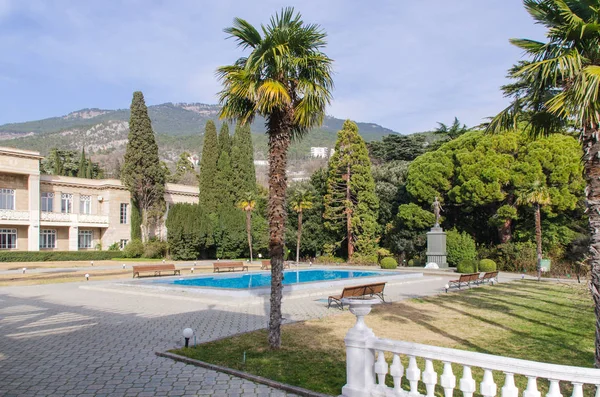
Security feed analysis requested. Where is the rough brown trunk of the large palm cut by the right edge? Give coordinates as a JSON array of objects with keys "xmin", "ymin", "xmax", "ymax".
[{"xmin": 582, "ymin": 126, "xmax": 600, "ymax": 368}]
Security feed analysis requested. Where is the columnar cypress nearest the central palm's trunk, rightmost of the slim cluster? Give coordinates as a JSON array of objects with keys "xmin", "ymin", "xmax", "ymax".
[{"xmin": 231, "ymin": 124, "xmax": 256, "ymax": 203}]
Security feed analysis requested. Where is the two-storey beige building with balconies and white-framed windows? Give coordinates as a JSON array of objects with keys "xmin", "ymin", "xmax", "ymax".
[{"xmin": 0, "ymin": 147, "xmax": 198, "ymax": 251}]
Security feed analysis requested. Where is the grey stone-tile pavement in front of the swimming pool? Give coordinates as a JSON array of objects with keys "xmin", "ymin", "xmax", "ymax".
[{"xmin": 0, "ymin": 270, "xmax": 458, "ymax": 397}]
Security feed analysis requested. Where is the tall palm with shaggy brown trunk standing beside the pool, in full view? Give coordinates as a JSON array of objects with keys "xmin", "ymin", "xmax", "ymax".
[{"xmin": 217, "ymin": 8, "xmax": 333, "ymax": 349}]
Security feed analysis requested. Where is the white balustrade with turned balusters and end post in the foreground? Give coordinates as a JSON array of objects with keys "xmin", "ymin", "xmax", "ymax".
[{"xmin": 342, "ymin": 299, "xmax": 600, "ymax": 397}]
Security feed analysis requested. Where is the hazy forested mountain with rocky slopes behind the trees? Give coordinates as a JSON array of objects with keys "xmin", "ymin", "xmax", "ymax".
[{"xmin": 0, "ymin": 103, "xmax": 395, "ymax": 169}]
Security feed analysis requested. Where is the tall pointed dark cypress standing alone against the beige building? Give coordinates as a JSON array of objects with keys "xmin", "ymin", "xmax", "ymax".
[{"xmin": 121, "ymin": 91, "xmax": 165, "ymax": 242}]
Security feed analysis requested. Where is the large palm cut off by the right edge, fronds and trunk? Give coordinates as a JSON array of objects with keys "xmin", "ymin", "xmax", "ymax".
[{"xmin": 487, "ymin": 0, "xmax": 600, "ymax": 367}]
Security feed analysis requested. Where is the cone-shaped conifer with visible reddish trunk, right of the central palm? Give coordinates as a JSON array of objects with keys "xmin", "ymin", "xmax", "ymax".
[{"xmin": 324, "ymin": 120, "xmax": 379, "ymax": 259}]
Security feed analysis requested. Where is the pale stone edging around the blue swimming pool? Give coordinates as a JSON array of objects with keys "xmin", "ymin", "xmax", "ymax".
[{"xmin": 119, "ymin": 266, "xmax": 423, "ymax": 298}]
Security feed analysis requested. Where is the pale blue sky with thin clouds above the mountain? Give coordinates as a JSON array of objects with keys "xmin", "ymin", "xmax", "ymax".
[{"xmin": 0, "ymin": 0, "xmax": 544, "ymax": 134}]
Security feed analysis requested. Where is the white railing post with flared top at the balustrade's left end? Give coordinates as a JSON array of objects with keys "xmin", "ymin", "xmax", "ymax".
[{"xmin": 342, "ymin": 299, "xmax": 380, "ymax": 397}]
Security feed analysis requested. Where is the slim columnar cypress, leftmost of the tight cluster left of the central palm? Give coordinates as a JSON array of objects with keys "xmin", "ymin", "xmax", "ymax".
[{"xmin": 199, "ymin": 120, "xmax": 220, "ymax": 213}]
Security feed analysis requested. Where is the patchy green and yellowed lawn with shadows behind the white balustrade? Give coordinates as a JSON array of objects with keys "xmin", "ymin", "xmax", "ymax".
[{"xmin": 174, "ymin": 281, "xmax": 594, "ymax": 395}]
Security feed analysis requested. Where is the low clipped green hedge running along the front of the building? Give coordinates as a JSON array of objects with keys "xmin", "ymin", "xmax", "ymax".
[{"xmin": 0, "ymin": 251, "xmax": 122, "ymax": 262}]
